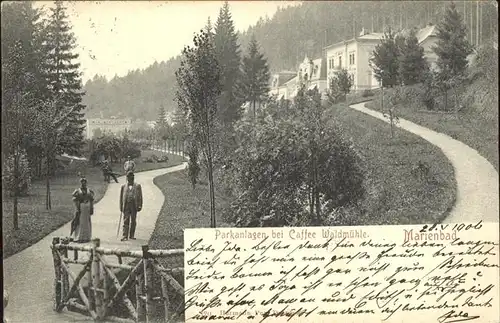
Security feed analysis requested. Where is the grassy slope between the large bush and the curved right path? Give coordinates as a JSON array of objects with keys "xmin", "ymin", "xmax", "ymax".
[{"xmin": 329, "ymin": 104, "xmax": 456, "ymax": 225}]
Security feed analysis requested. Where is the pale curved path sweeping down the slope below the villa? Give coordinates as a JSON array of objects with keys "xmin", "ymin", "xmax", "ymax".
[{"xmin": 350, "ymin": 102, "xmax": 499, "ymax": 223}]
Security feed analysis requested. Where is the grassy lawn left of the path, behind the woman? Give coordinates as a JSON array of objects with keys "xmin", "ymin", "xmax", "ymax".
[{"xmin": 2, "ymin": 151, "xmax": 183, "ymax": 259}]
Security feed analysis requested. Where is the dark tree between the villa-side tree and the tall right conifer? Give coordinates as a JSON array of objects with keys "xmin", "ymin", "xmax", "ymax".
[{"xmin": 399, "ymin": 30, "xmax": 428, "ymax": 85}]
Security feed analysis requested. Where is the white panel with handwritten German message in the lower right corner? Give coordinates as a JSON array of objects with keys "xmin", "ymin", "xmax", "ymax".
[{"xmin": 184, "ymin": 223, "xmax": 500, "ymax": 323}]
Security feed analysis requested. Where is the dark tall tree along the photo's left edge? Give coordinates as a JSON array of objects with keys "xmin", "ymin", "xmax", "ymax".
[{"xmin": 1, "ymin": 1, "xmax": 44, "ymax": 230}]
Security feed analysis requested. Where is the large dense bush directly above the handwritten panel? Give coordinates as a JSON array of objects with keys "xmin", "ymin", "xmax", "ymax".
[{"xmin": 222, "ymin": 91, "xmax": 364, "ymax": 227}]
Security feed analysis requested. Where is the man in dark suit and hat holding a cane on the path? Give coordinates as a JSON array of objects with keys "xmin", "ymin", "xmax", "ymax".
[{"xmin": 120, "ymin": 172, "xmax": 142, "ymax": 241}]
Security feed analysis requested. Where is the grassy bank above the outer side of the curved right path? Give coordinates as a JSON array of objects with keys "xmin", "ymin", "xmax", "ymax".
[{"xmin": 366, "ymin": 93, "xmax": 499, "ymax": 171}]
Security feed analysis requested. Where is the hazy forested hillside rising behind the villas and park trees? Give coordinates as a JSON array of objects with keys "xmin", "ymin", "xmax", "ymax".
[{"xmin": 84, "ymin": 1, "xmax": 498, "ymax": 120}]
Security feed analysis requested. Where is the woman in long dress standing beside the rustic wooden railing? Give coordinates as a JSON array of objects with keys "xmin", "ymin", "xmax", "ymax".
[{"xmin": 71, "ymin": 178, "xmax": 94, "ymax": 242}]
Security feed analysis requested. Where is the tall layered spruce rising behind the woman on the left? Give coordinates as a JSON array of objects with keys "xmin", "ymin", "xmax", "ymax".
[{"xmin": 44, "ymin": 1, "xmax": 85, "ymax": 155}]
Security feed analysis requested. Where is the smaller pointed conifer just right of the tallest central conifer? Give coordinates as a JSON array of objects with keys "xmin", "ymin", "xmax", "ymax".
[{"xmin": 239, "ymin": 36, "xmax": 270, "ymax": 118}]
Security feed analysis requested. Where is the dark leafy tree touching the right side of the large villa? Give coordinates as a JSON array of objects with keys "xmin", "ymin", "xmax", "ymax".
[{"xmin": 370, "ymin": 28, "xmax": 399, "ymax": 87}]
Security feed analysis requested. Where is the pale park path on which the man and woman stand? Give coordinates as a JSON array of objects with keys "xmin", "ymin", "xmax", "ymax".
[{"xmin": 3, "ymin": 163, "xmax": 186, "ymax": 323}]
